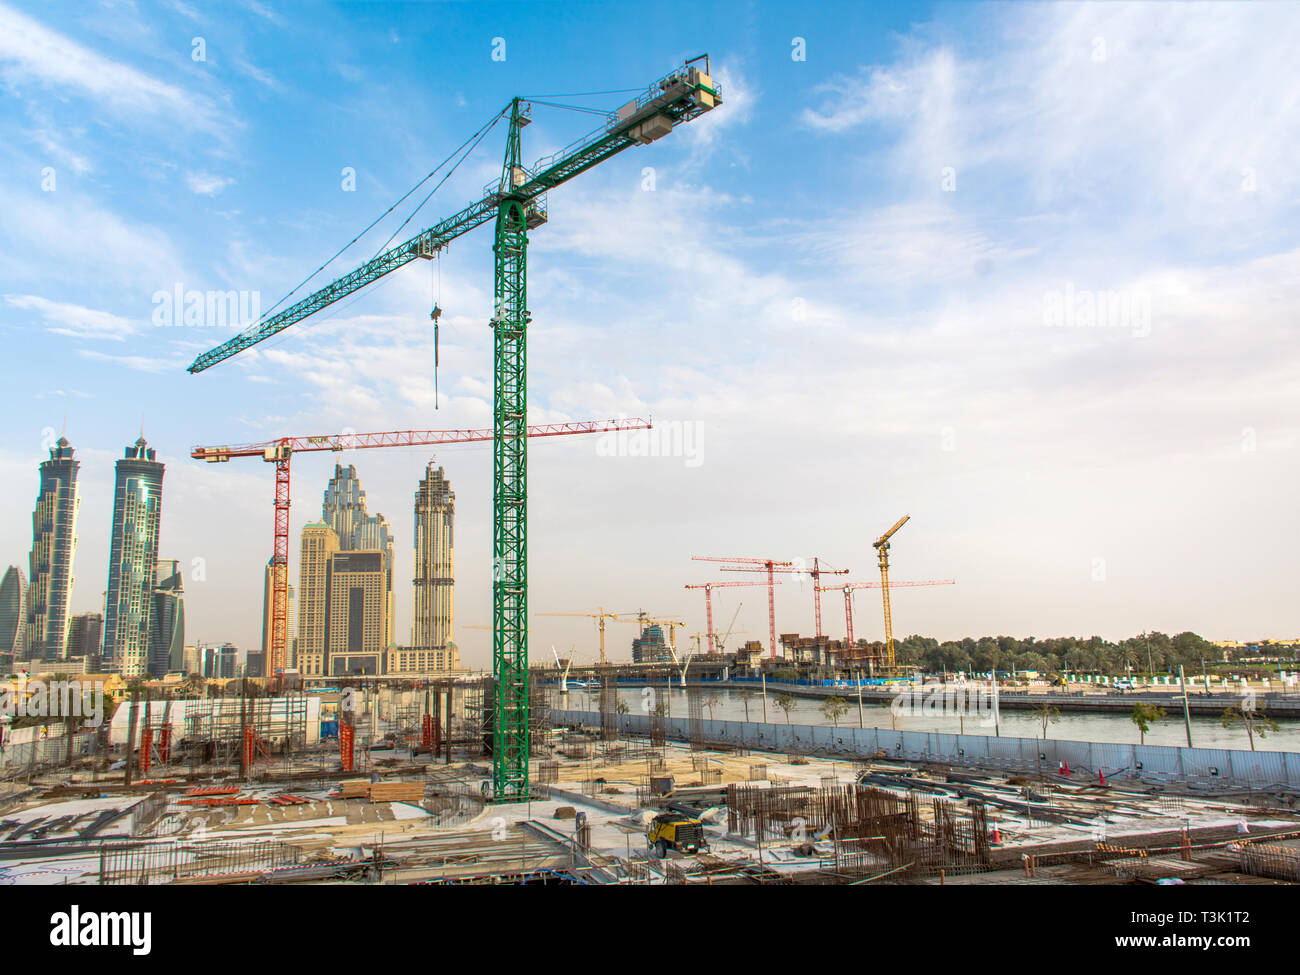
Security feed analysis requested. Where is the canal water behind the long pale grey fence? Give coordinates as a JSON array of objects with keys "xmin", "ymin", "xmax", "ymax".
[{"xmin": 559, "ymin": 684, "xmax": 1300, "ymax": 751}]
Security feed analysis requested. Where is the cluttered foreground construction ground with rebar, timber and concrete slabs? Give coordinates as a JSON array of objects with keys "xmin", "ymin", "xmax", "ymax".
[{"xmin": 0, "ymin": 670, "xmax": 1300, "ymax": 885}]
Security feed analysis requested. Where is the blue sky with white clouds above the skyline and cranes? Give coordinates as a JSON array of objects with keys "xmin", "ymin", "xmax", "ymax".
[{"xmin": 0, "ymin": 1, "xmax": 1300, "ymax": 664}]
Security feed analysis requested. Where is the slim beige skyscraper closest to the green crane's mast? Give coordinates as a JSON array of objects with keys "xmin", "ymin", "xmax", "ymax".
[{"xmin": 411, "ymin": 462, "xmax": 456, "ymax": 650}]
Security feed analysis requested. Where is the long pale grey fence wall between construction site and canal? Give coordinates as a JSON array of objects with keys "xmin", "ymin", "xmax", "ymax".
[{"xmin": 551, "ymin": 710, "xmax": 1300, "ymax": 789}]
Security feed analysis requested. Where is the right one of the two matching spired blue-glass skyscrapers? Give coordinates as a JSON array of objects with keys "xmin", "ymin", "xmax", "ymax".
[{"xmin": 104, "ymin": 437, "xmax": 163, "ymax": 677}]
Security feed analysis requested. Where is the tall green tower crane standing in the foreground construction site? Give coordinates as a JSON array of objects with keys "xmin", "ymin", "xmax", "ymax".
[{"xmin": 189, "ymin": 55, "xmax": 722, "ymax": 801}]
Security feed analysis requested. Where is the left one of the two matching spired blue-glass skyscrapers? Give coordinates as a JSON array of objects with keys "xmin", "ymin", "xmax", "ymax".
[{"xmin": 26, "ymin": 437, "xmax": 81, "ymax": 660}]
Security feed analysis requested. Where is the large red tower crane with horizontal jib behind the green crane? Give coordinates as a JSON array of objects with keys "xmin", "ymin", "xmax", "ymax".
[{"xmin": 190, "ymin": 419, "xmax": 650, "ymax": 677}]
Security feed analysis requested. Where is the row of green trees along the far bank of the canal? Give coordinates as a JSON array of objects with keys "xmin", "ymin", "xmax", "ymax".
[{"xmin": 894, "ymin": 632, "xmax": 1242, "ymax": 673}]
